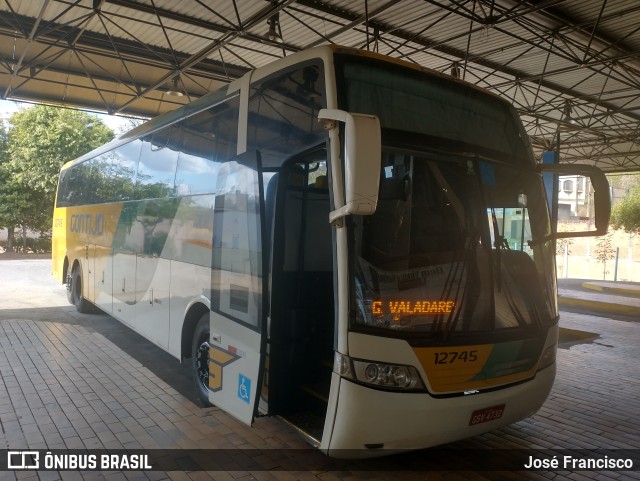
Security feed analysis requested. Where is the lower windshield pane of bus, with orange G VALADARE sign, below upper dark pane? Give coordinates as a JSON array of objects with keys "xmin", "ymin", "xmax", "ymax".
[{"xmin": 352, "ymin": 150, "xmax": 555, "ymax": 337}]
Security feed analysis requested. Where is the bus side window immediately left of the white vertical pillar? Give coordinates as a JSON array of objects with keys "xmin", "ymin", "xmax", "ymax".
[{"xmin": 175, "ymin": 97, "xmax": 239, "ymax": 195}]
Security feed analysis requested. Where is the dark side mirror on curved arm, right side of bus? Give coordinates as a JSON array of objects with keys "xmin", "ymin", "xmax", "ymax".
[{"xmin": 538, "ymin": 164, "xmax": 611, "ymax": 239}]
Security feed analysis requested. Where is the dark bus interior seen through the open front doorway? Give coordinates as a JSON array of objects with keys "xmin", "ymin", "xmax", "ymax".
[{"xmin": 263, "ymin": 148, "xmax": 335, "ymax": 443}]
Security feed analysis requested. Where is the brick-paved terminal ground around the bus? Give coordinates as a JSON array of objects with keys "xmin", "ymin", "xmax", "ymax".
[{"xmin": 0, "ymin": 255, "xmax": 640, "ymax": 481}]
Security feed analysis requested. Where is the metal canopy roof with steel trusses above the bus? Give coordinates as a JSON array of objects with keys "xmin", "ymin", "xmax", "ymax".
[{"xmin": 0, "ymin": 0, "xmax": 640, "ymax": 172}]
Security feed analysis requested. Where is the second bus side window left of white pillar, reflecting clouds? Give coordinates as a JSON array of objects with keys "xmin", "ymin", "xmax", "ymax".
[{"xmin": 136, "ymin": 126, "xmax": 182, "ymax": 199}]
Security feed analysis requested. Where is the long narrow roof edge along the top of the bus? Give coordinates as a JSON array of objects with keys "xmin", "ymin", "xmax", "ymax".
[{"xmin": 62, "ymin": 44, "xmax": 511, "ymax": 169}]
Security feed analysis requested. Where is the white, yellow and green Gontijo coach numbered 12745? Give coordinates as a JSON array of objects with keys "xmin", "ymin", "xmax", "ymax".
[{"xmin": 52, "ymin": 46, "xmax": 609, "ymax": 457}]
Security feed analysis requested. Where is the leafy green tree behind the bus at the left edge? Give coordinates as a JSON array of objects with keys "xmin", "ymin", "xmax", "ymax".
[{"xmin": 0, "ymin": 105, "xmax": 113, "ymax": 248}]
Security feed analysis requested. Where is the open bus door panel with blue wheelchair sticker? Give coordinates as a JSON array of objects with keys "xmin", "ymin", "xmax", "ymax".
[{"xmin": 209, "ymin": 152, "xmax": 267, "ymax": 425}]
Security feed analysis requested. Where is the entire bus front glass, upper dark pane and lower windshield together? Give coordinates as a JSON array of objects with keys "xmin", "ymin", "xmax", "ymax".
[{"xmin": 336, "ymin": 56, "xmax": 557, "ymax": 340}]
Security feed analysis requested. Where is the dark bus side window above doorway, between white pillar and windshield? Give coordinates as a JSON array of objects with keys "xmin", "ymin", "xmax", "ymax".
[{"xmin": 247, "ymin": 61, "xmax": 326, "ymax": 168}]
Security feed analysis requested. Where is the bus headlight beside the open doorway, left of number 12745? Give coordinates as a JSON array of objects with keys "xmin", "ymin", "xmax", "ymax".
[{"xmin": 334, "ymin": 352, "xmax": 426, "ymax": 391}]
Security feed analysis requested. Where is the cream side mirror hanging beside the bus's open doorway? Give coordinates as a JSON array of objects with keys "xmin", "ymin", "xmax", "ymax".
[{"xmin": 318, "ymin": 109, "xmax": 382, "ymax": 222}]
